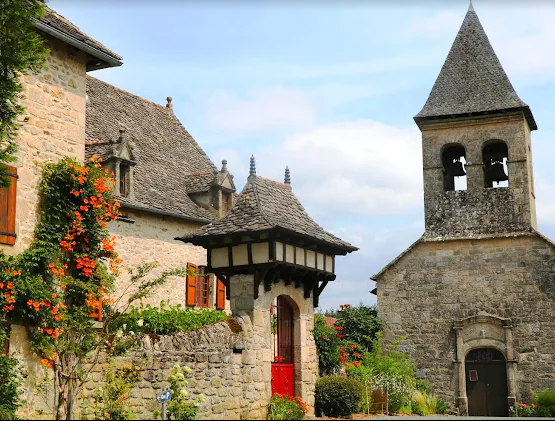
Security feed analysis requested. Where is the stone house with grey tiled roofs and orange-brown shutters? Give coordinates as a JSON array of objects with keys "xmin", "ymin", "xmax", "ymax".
[{"xmin": 0, "ymin": 3, "xmax": 235, "ymax": 309}]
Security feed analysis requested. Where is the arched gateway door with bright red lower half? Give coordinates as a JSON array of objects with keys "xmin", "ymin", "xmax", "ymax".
[{"xmin": 270, "ymin": 295, "xmax": 295, "ymax": 397}]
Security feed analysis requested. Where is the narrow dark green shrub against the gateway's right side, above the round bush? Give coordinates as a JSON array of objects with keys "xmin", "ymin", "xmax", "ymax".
[{"xmin": 312, "ymin": 314, "xmax": 341, "ymax": 376}]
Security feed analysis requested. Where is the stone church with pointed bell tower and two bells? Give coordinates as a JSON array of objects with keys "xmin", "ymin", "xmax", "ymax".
[{"xmin": 372, "ymin": 6, "xmax": 555, "ymax": 416}]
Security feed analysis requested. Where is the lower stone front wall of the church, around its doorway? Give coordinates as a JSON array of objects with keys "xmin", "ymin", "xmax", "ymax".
[{"xmin": 377, "ymin": 234, "xmax": 555, "ymax": 407}]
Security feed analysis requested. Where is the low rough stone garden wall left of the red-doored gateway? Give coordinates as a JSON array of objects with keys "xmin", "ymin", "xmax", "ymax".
[{"xmin": 78, "ymin": 318, "xmax": 270, "ymax": 420}]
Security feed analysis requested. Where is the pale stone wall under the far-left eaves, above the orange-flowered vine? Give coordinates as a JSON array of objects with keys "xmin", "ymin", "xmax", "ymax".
[{"xmin": 0, "ymin": 37, "xmax": 86, "ymax": 254}]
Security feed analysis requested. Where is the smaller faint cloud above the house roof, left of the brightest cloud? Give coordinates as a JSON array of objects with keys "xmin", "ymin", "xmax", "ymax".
[{"xmin": 206, "ymin": 87, "xmax": 316, "ymax": 133}]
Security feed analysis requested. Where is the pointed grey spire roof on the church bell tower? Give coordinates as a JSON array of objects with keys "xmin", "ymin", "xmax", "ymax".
[{"xmin": 414, "ymin": 5, "xmax": 537, "ymax": 130}]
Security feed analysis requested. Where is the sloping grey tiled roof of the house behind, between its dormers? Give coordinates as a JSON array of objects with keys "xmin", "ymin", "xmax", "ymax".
[{"xmin": 85, "ymin": 76, "xmax": 217, "ymax": 222}]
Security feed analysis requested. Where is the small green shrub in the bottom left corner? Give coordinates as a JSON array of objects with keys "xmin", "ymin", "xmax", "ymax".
[{"xmin": 0, "ymin": 355, "xmax": 23, "ymax": 420}]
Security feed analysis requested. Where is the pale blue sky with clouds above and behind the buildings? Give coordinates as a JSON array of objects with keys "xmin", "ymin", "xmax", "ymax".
[{"xmin": 48, "ymin": 0, "xmax": 555, "ymax": 309}]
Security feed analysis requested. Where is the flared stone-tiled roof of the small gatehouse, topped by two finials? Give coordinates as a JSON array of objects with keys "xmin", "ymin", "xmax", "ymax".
[{"xmin": 180, "ymin": 171, "xmax": 358, "ymax": 254}]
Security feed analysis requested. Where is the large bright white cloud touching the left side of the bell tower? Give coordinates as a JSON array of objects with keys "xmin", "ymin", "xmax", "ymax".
[{"xmin": 257, "ymin": 120, "xmax": 422, "ymax": 217}]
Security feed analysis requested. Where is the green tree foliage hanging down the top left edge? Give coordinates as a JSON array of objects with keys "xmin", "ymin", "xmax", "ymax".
[{"xmin": 0, "ymin": 0, "xmax": 48, "ymax": 188}]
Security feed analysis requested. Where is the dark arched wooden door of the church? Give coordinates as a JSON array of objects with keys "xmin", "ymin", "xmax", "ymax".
[{"xmin": 465, "ymin": 348, "xmax": 509, "ymax": 417}]
